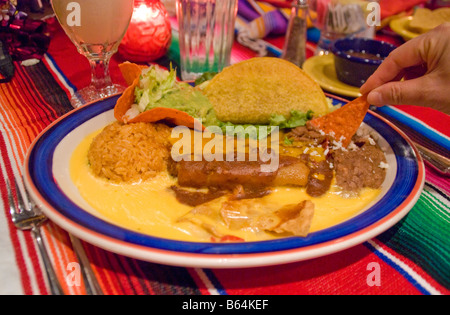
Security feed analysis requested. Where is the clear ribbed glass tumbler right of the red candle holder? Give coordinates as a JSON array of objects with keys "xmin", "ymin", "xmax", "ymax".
[{"xmin": 177, "ymin": 0, "xmax": 238, "ymax": 80}]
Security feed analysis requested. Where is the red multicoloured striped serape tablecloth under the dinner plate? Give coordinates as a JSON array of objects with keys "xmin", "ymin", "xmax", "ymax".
[{"xmin": 0, "ymin": 5, "xmax": 450, "ymax": 295}]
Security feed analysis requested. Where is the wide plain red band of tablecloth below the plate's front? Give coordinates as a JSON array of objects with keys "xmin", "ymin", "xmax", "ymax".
[{"xmin": 209, "ymin": 245, "xmax": 420, "ymax": 295}]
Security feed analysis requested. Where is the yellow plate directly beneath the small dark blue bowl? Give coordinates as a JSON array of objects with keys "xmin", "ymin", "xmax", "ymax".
[{"xmin": 303, "ymin": 55, "xmax": 361, "ymax": 98}]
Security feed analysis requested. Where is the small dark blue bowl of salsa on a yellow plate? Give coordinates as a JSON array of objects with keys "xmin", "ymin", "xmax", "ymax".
[{"xmin": 331, "ymin": 38, "xmax": 396, "ymax": 87}]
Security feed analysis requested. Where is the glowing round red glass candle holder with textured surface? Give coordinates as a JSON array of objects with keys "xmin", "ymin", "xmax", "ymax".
[{"xmin": 119, "ymin": 0, "xmax": 172, "ymax": 62}]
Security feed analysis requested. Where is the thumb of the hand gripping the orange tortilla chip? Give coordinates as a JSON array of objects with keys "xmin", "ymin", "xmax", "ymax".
[{"xmin": 367, "ymin": 77, "xmax": 430, "ymax": 106}]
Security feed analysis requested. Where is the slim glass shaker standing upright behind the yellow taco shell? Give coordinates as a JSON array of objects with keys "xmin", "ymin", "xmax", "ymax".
[{"xmin": 281, "ymin": 0, "xmax": 308, "ymax": 67}]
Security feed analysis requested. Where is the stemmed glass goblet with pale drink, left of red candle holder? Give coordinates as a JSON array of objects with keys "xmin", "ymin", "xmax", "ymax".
[{"xmin": 52, "ymin": 0, "xmax": 134, "ymax": 108}]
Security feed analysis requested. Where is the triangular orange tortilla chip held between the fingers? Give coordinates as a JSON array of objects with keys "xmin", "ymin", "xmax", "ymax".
[{"xmin": 308, "ymin": 95, "xmax": 370, "ymax": 148}]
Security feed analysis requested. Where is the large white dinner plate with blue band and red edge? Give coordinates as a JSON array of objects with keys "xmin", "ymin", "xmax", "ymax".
[{"xmin": 24, "ymin": 95, "xmax": 425, "ymax": 268}]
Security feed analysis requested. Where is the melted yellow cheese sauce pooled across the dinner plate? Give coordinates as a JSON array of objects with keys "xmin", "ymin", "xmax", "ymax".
[{"xmin": 70, "ymin": 131, "xmax": 380, "ymax": 242}]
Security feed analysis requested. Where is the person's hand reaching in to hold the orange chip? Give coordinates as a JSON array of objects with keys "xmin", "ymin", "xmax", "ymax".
[{"xmin": 360, "ymin": 23, "xmax": 450, "ymax": 114}]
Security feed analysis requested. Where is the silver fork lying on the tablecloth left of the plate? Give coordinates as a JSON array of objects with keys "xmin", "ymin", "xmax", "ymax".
[{"xmin": 6, "ymin": 180, "xmax": 64, "ymax": 295}]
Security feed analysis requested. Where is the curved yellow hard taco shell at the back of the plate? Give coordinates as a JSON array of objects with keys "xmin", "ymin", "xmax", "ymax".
[{"xmin": 204, "ymin": 57, "xmax": 329, "ymax": 125}]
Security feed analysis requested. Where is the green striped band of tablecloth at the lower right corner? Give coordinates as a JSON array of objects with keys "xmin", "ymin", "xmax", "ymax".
[{"xmin": 378, "ymin": 186, "xmax": 450, "ymax": 289}]
